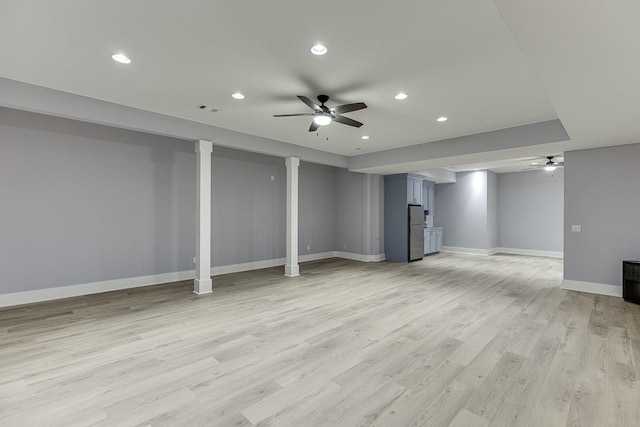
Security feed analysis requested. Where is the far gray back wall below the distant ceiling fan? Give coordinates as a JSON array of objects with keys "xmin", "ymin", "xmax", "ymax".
[{"xmin": 498, "ymin": 168, "xmax": 564, "ymax": 252}]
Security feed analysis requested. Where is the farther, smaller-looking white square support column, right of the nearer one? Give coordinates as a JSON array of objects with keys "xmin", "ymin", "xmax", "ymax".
[{"xmin": 284, "ymin": 157, "xmax": 300, "ymax": 277}]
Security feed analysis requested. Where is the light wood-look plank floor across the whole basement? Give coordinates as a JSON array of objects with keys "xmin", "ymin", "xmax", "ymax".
[{"xmin": 0, "ymin": 253, "xmax": 640, "ymax": 427}]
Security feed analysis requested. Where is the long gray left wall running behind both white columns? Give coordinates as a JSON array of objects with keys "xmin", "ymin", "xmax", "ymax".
[{"xmin": 0, "ymin": 108, "xmax": 381, "ymax": 293}]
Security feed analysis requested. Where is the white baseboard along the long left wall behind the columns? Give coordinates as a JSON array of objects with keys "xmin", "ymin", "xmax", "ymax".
[{"xmin": 0, "ymin": 251, "xmax": 385, "ymax": 307}]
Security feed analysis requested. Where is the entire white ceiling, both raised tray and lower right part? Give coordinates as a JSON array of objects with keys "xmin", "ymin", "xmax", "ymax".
[{"xmin": 0, "ymin": 0, "xmax": 640, "ymax": 173}]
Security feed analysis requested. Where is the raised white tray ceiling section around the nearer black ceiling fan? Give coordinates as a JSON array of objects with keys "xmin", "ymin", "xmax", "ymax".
[{"xmin": 0, "ymin": 0, "xmax": 556, "ymax": 155}]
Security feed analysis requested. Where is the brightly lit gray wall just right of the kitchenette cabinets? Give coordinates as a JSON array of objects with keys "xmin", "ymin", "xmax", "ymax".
[{"xmin": 434, "ymin": 171, "xmax": 492, "ymax": 249}]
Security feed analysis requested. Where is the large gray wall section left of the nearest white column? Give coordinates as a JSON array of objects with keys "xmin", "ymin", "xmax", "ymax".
[{"xmin": 0, "ymin": 108, "xmax": 195, "ymax": 293}]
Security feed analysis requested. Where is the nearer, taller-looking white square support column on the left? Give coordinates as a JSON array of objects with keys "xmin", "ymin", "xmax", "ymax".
[{"xmin": 193, "ymin": 139, "xmax": 213, "ymax": 295}]
